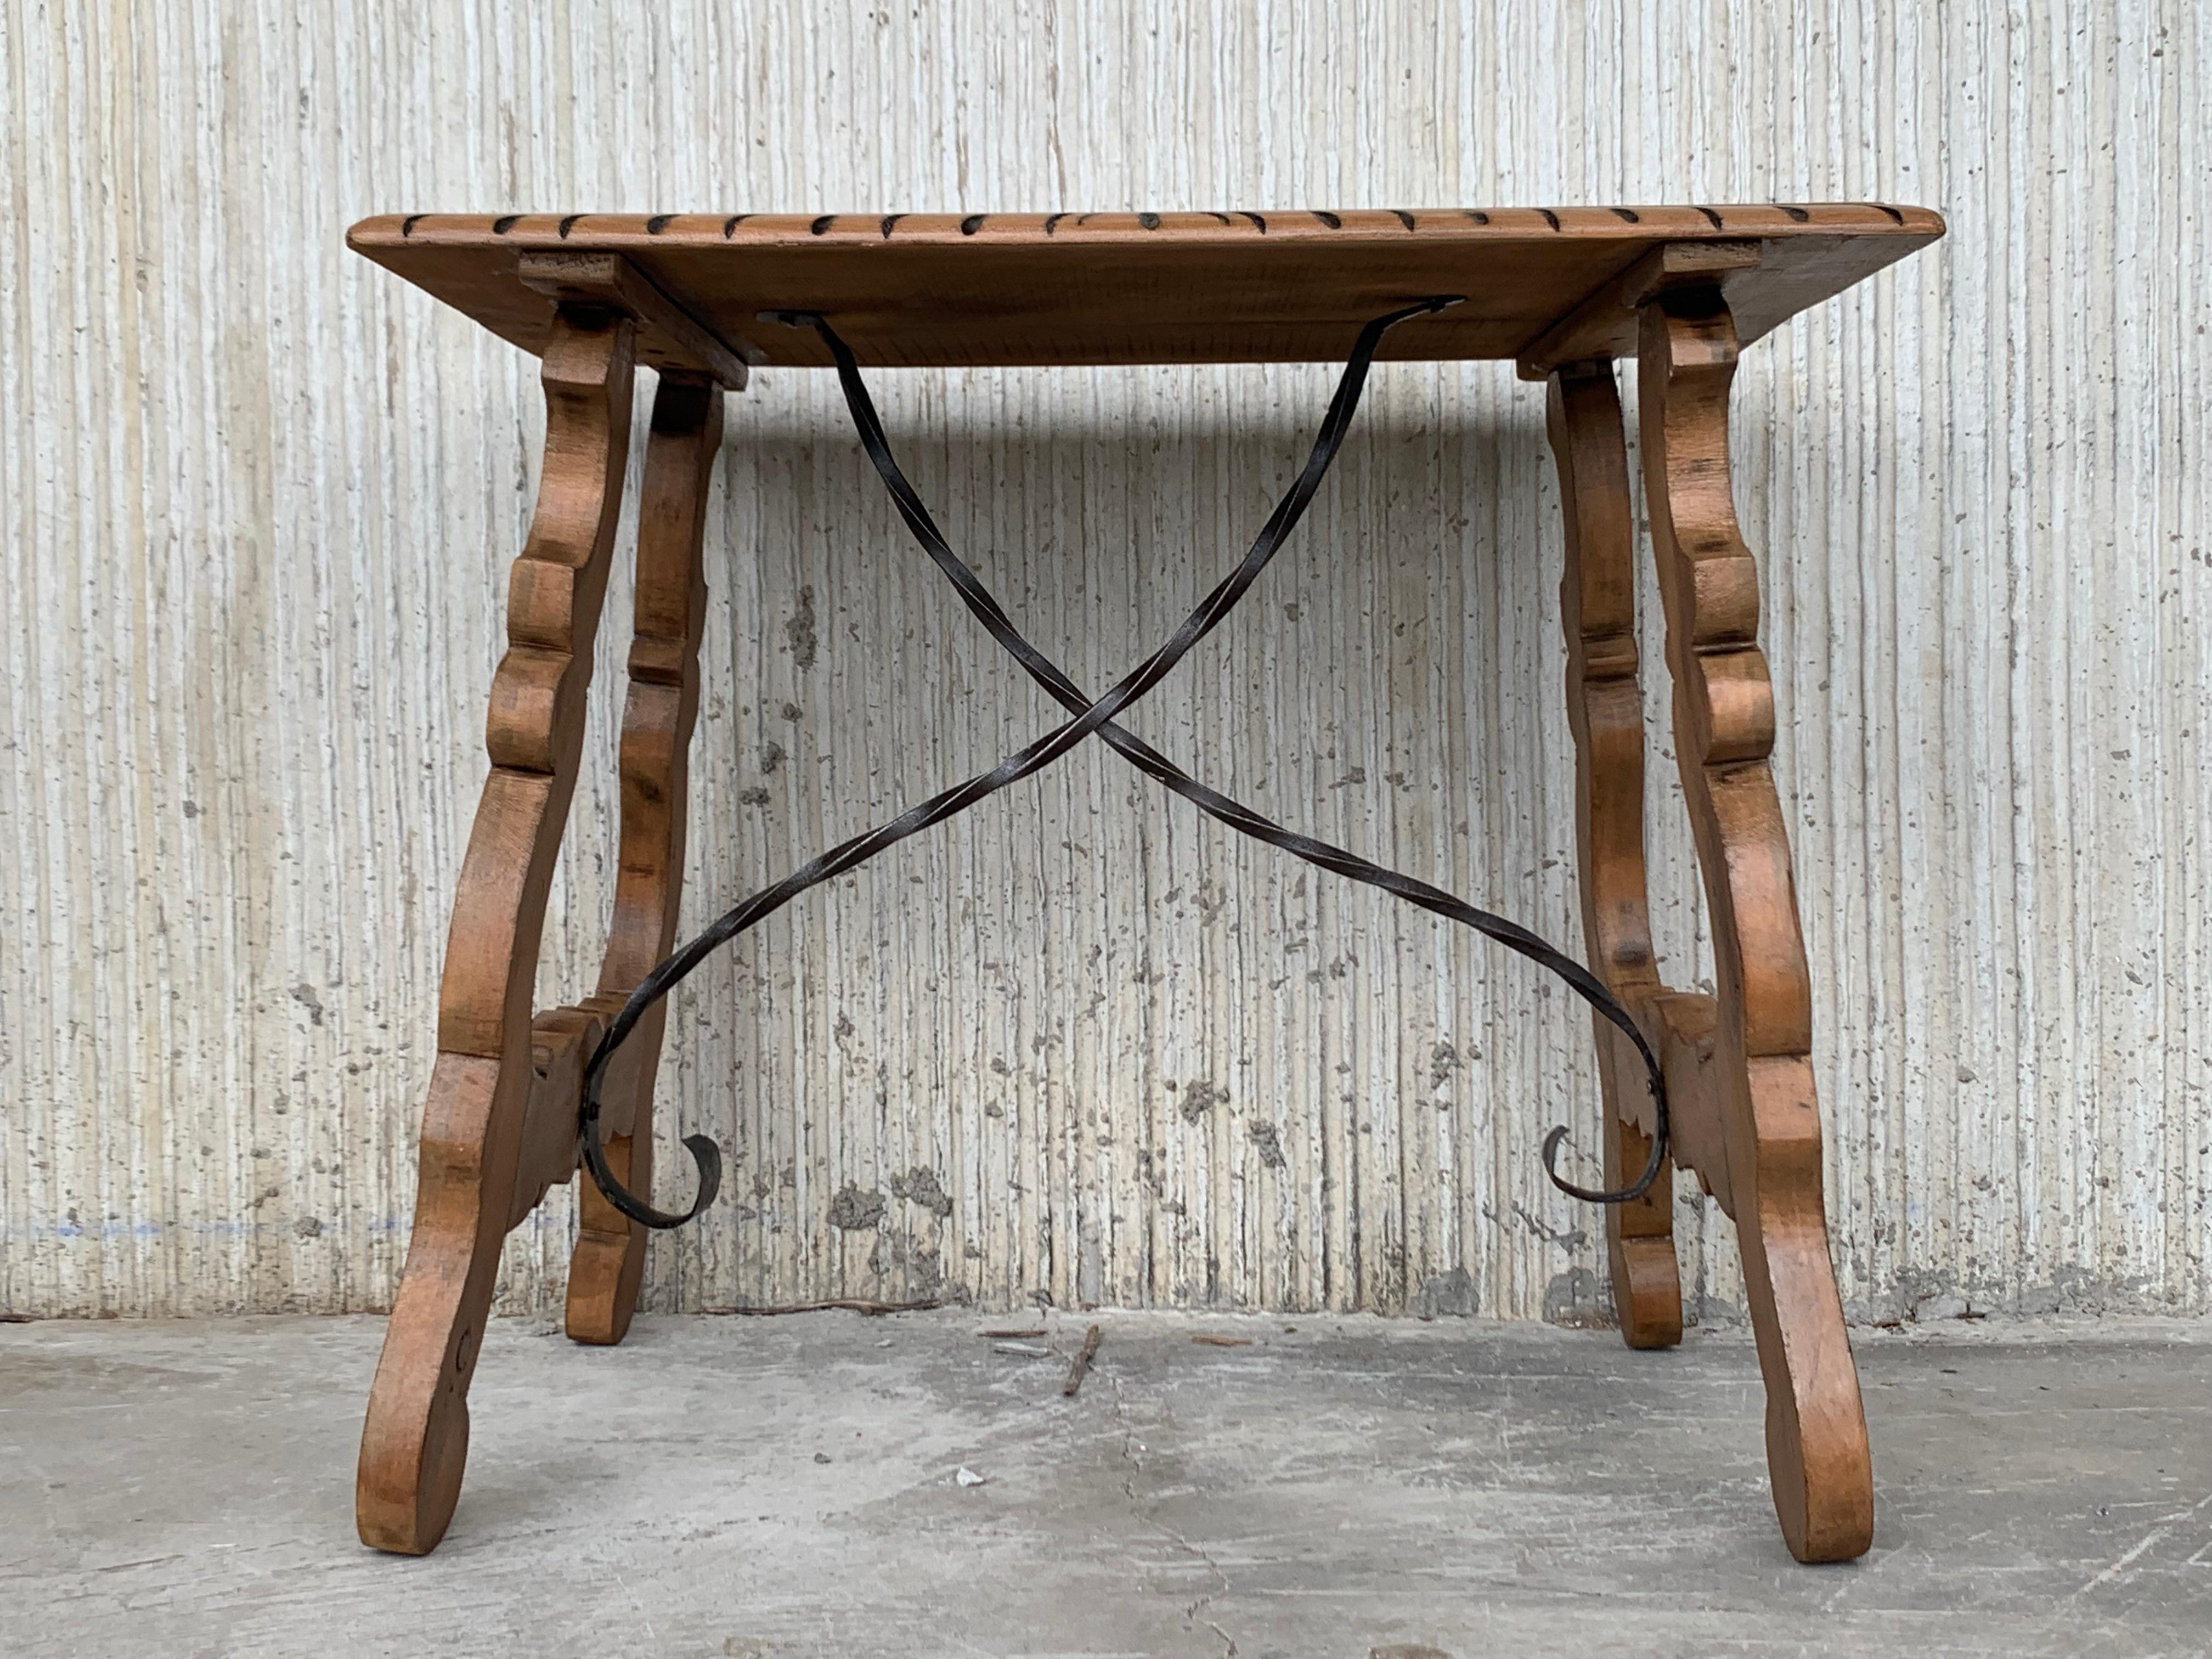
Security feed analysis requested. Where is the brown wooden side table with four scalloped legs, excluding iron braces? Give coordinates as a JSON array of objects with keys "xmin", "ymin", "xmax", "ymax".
[{"xmin": 347, "ymin": 204, "xmax": 1942, "ymax": 1562}]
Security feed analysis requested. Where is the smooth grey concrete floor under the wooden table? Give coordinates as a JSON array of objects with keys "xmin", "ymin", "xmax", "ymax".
[{"xmin": 0, "ymin": 1312, "xmax": 2212, "ymax": 1659}]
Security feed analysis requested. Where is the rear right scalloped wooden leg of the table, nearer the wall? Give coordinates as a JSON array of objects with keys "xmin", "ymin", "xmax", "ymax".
[{"xmin": 1548, "ymin": 363, "xmax": 1681, "ymax": 1347}]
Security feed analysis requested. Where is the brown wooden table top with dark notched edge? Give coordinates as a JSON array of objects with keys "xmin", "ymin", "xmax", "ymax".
[{"xmin": 347, "ymin": 204, "xmax": 1944, "ymax": 367}]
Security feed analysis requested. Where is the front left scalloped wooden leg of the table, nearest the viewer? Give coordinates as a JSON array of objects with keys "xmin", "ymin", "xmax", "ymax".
[{"xmin": 354, "ymin": 309, "xmax": 633, "ymax": 1555}]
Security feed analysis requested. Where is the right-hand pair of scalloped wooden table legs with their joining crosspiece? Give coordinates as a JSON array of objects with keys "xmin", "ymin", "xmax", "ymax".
[{"xmin": 1550, "ymin": 281, "xmax": 1874, "ymax": 1562}]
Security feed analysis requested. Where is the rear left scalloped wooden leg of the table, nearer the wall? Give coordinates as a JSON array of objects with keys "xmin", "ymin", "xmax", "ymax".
[{"xmin": 568, "ymin": 376, "xmax": 721, "ymax": 1342}]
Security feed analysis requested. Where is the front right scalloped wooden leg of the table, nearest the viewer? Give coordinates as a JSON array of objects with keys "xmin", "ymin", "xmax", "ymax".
[{"xmin": 1637, "ymin": 287, "xmax": 1874, "ymax": 1562}]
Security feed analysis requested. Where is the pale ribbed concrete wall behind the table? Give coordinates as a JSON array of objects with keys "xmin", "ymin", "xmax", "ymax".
[{"xmin": 0, "ymin": 0, "xmax": 2212, "ymax": 1316}]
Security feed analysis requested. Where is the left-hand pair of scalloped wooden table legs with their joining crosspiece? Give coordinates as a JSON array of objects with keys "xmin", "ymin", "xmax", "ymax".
[{"xmin": 354, "ymin": 296, "xmax": 721, "ymax": 1555}]
